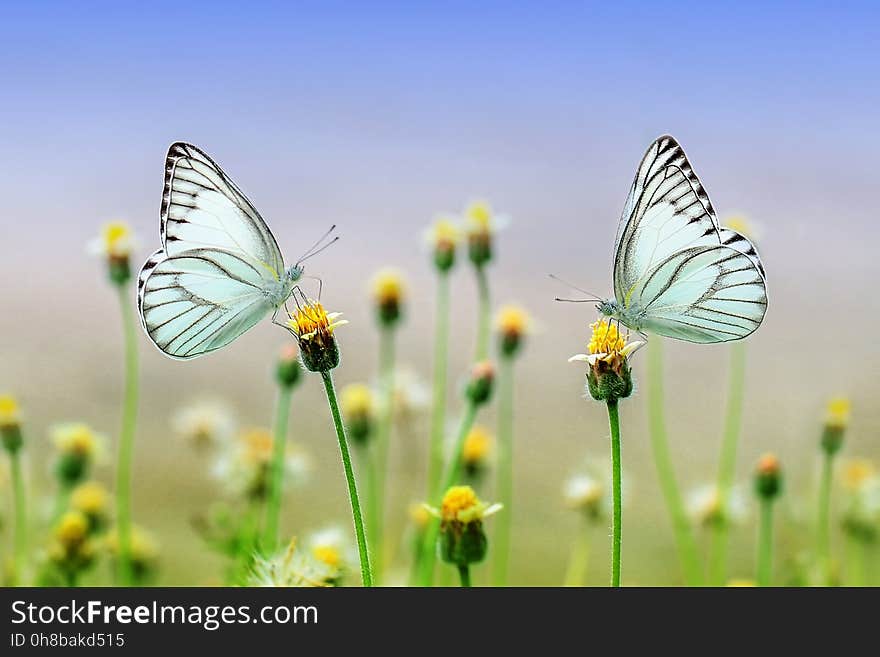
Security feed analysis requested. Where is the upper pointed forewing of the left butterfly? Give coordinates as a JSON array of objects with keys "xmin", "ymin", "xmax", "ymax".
[{"xmin": 161, "ymin": 142, "xmax": 284, "ymax": 280}]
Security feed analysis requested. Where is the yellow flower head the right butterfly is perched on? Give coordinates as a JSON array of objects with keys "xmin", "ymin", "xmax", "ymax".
[{"xmin": 568, "ymin": 319, "xmax": 645, "ymax": 401}]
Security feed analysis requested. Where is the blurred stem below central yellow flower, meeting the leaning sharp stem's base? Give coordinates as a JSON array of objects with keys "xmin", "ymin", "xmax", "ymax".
[{"xmin": 370, "ymin": 326, "xmax": 394, "ymax": 581}]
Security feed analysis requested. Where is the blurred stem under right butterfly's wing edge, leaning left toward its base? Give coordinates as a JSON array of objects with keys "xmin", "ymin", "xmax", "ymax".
[{"xmin": 709, "ymin": 341, "xmax": 746, "ymax": 586}]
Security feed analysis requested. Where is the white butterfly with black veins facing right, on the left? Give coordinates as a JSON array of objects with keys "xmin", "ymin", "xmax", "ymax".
[{"xmin": 138, "ymin": 142, "xmax": 335, "ymax": 360}]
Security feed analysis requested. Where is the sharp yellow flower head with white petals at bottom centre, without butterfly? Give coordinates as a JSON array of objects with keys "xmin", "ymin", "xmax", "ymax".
[{"xmin": 431, "ymin": 486, "xmax": 501, "ymax": 566}]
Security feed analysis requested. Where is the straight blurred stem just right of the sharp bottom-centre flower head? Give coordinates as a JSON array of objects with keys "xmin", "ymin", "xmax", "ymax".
[{"xmin": 492, "ymin": 356, "xmax": 514, "ymax": 586}]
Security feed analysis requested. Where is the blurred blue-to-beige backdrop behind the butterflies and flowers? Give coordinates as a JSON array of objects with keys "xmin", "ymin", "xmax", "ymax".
[{"xmin": 0, "ymin": 1, "xmax": 880, "ymax": 585}]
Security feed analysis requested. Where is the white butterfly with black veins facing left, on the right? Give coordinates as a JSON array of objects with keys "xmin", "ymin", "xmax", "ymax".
[{"xmin": 597, "ymin": 135, "xmax": 767, "ymax": 343}]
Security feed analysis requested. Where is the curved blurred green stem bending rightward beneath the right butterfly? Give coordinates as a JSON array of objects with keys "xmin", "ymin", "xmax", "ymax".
[{"xmin": 648, "ymin": 338, "xmax": 703, "ymax": 586}]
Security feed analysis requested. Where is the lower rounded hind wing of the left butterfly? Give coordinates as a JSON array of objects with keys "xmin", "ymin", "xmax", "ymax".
[{"xmin": 138, "ymin": 248, "xmax": 273, "ymax": 360}]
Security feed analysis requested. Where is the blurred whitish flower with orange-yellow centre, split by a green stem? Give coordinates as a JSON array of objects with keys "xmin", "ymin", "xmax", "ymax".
[{"xmin": 214, "ymin": 427, "xmax": 309, "ymax": 500}]
